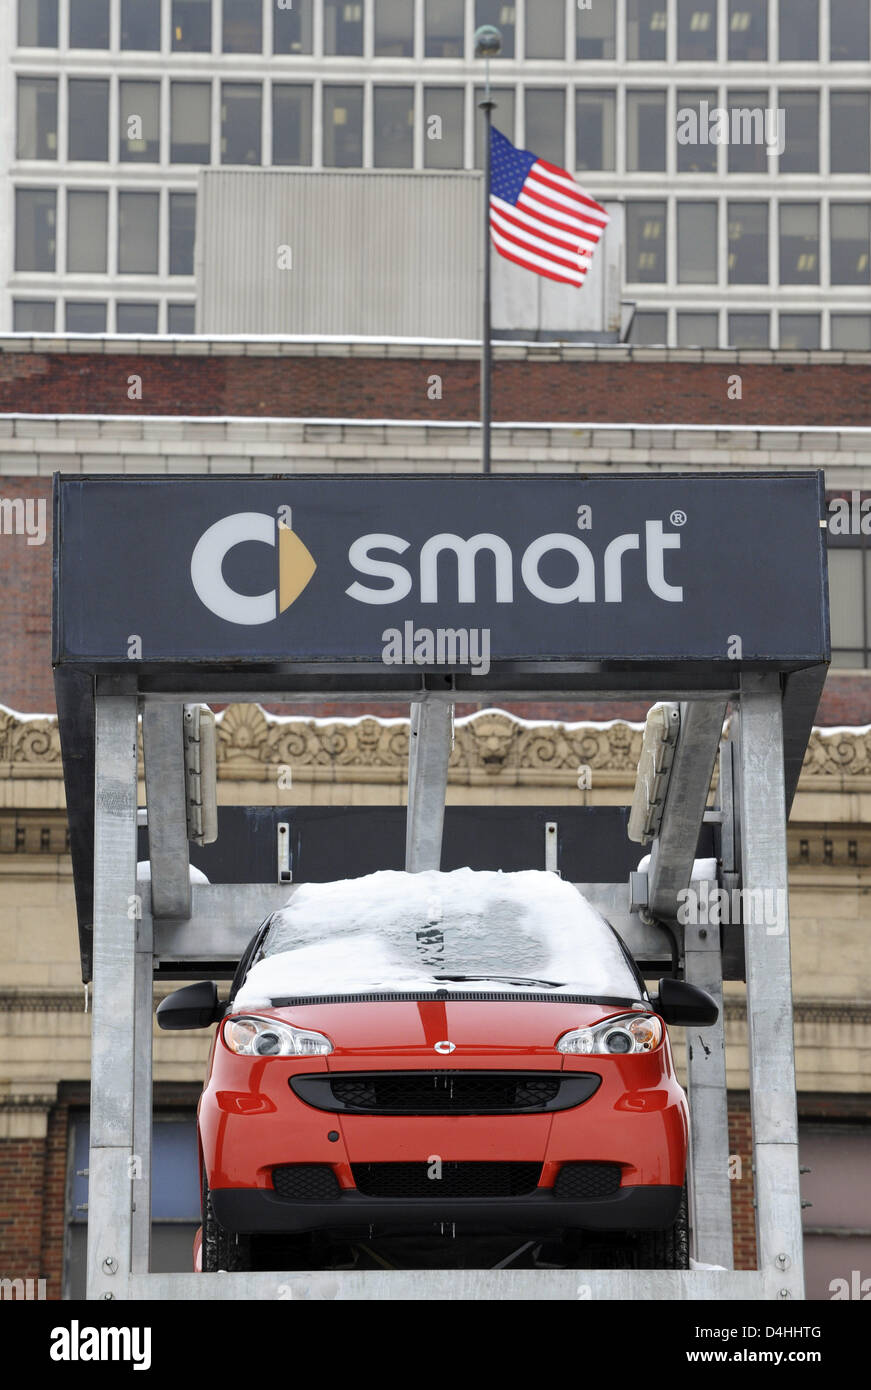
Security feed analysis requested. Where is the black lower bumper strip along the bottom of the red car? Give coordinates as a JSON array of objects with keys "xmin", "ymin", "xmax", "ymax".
[{"xmin": 211, "ymin": 1186, "xmax": 682, "ymax": 1234}]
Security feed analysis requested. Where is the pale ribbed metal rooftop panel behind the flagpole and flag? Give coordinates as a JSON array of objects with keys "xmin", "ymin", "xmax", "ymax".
[{"xmin": 196, "ymin": 170, "xmax": 622, "ymax": 339}]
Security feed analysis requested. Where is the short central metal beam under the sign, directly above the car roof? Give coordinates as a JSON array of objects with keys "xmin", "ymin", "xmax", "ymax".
[{"xmin": 406, "ymin": 701, "xmax": 454, "ymax": 873}]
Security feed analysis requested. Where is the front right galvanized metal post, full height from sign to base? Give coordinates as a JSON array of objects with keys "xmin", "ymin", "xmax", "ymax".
[{"xmin": 739, "ymin": 676, "xmax": 804, "ymax": 1298}]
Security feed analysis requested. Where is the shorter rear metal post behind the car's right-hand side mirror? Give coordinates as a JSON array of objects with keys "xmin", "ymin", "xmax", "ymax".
[{"xmin": 683, "ymin": 923, "xmax": 733, "ymax": 1269}]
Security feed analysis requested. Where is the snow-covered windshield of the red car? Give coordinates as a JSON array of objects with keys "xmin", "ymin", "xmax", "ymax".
[{"xmin": 235, "ymin": 869, "xmax": 639, "ymax": 1008}]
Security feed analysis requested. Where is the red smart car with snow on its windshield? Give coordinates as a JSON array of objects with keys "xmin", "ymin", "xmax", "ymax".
[{"xmin": 157, "ymin": 869, "xmax": 717, "ymax": 1270}]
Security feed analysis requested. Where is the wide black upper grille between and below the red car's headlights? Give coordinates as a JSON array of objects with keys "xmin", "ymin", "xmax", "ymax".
[{"xmin": 289, "ymin": 1069, "xmax": 602, "ymax": 1115}]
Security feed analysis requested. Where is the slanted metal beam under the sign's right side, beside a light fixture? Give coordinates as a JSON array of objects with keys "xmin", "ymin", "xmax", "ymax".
[{"xmin": 647, "ymin": 699, "xmax": 727, "ymax": 922}]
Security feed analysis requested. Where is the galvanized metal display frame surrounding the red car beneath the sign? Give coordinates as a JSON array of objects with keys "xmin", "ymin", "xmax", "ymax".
[{"xmin": 56, "ymin": 480, "xmax": 828, "ymax": 1301}]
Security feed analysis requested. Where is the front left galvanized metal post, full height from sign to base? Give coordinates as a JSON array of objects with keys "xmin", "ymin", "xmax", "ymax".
[{"xmin": 88, "ymin": 692, "xmax": 136, "ymax": 1298}]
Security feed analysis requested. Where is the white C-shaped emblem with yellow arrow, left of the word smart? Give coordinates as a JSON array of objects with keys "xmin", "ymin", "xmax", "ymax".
[{"xmin": 190, "ymin": 506, "xmax": 317, "ymax": 627}]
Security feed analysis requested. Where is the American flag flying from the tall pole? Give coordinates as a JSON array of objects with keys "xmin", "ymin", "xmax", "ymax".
[{"xmin": 490, "ymin": 126, "xmax": 608, "ymax": 286}]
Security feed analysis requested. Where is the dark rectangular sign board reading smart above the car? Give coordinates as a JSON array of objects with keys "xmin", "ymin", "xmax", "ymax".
[{"xmin": 54, "ymin": 474, "xmax": 828, "ymax": 677}]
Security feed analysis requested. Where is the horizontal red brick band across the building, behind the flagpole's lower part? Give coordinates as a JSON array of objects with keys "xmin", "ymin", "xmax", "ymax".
[{"xmin": 0, "ymin": 350, "xmax": 871, "ymax": 427}]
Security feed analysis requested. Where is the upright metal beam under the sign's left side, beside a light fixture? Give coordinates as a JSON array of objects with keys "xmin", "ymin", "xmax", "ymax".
[{"xmin": 142, "ymin": 703, "xmax": 190, "ymax": 917}]
